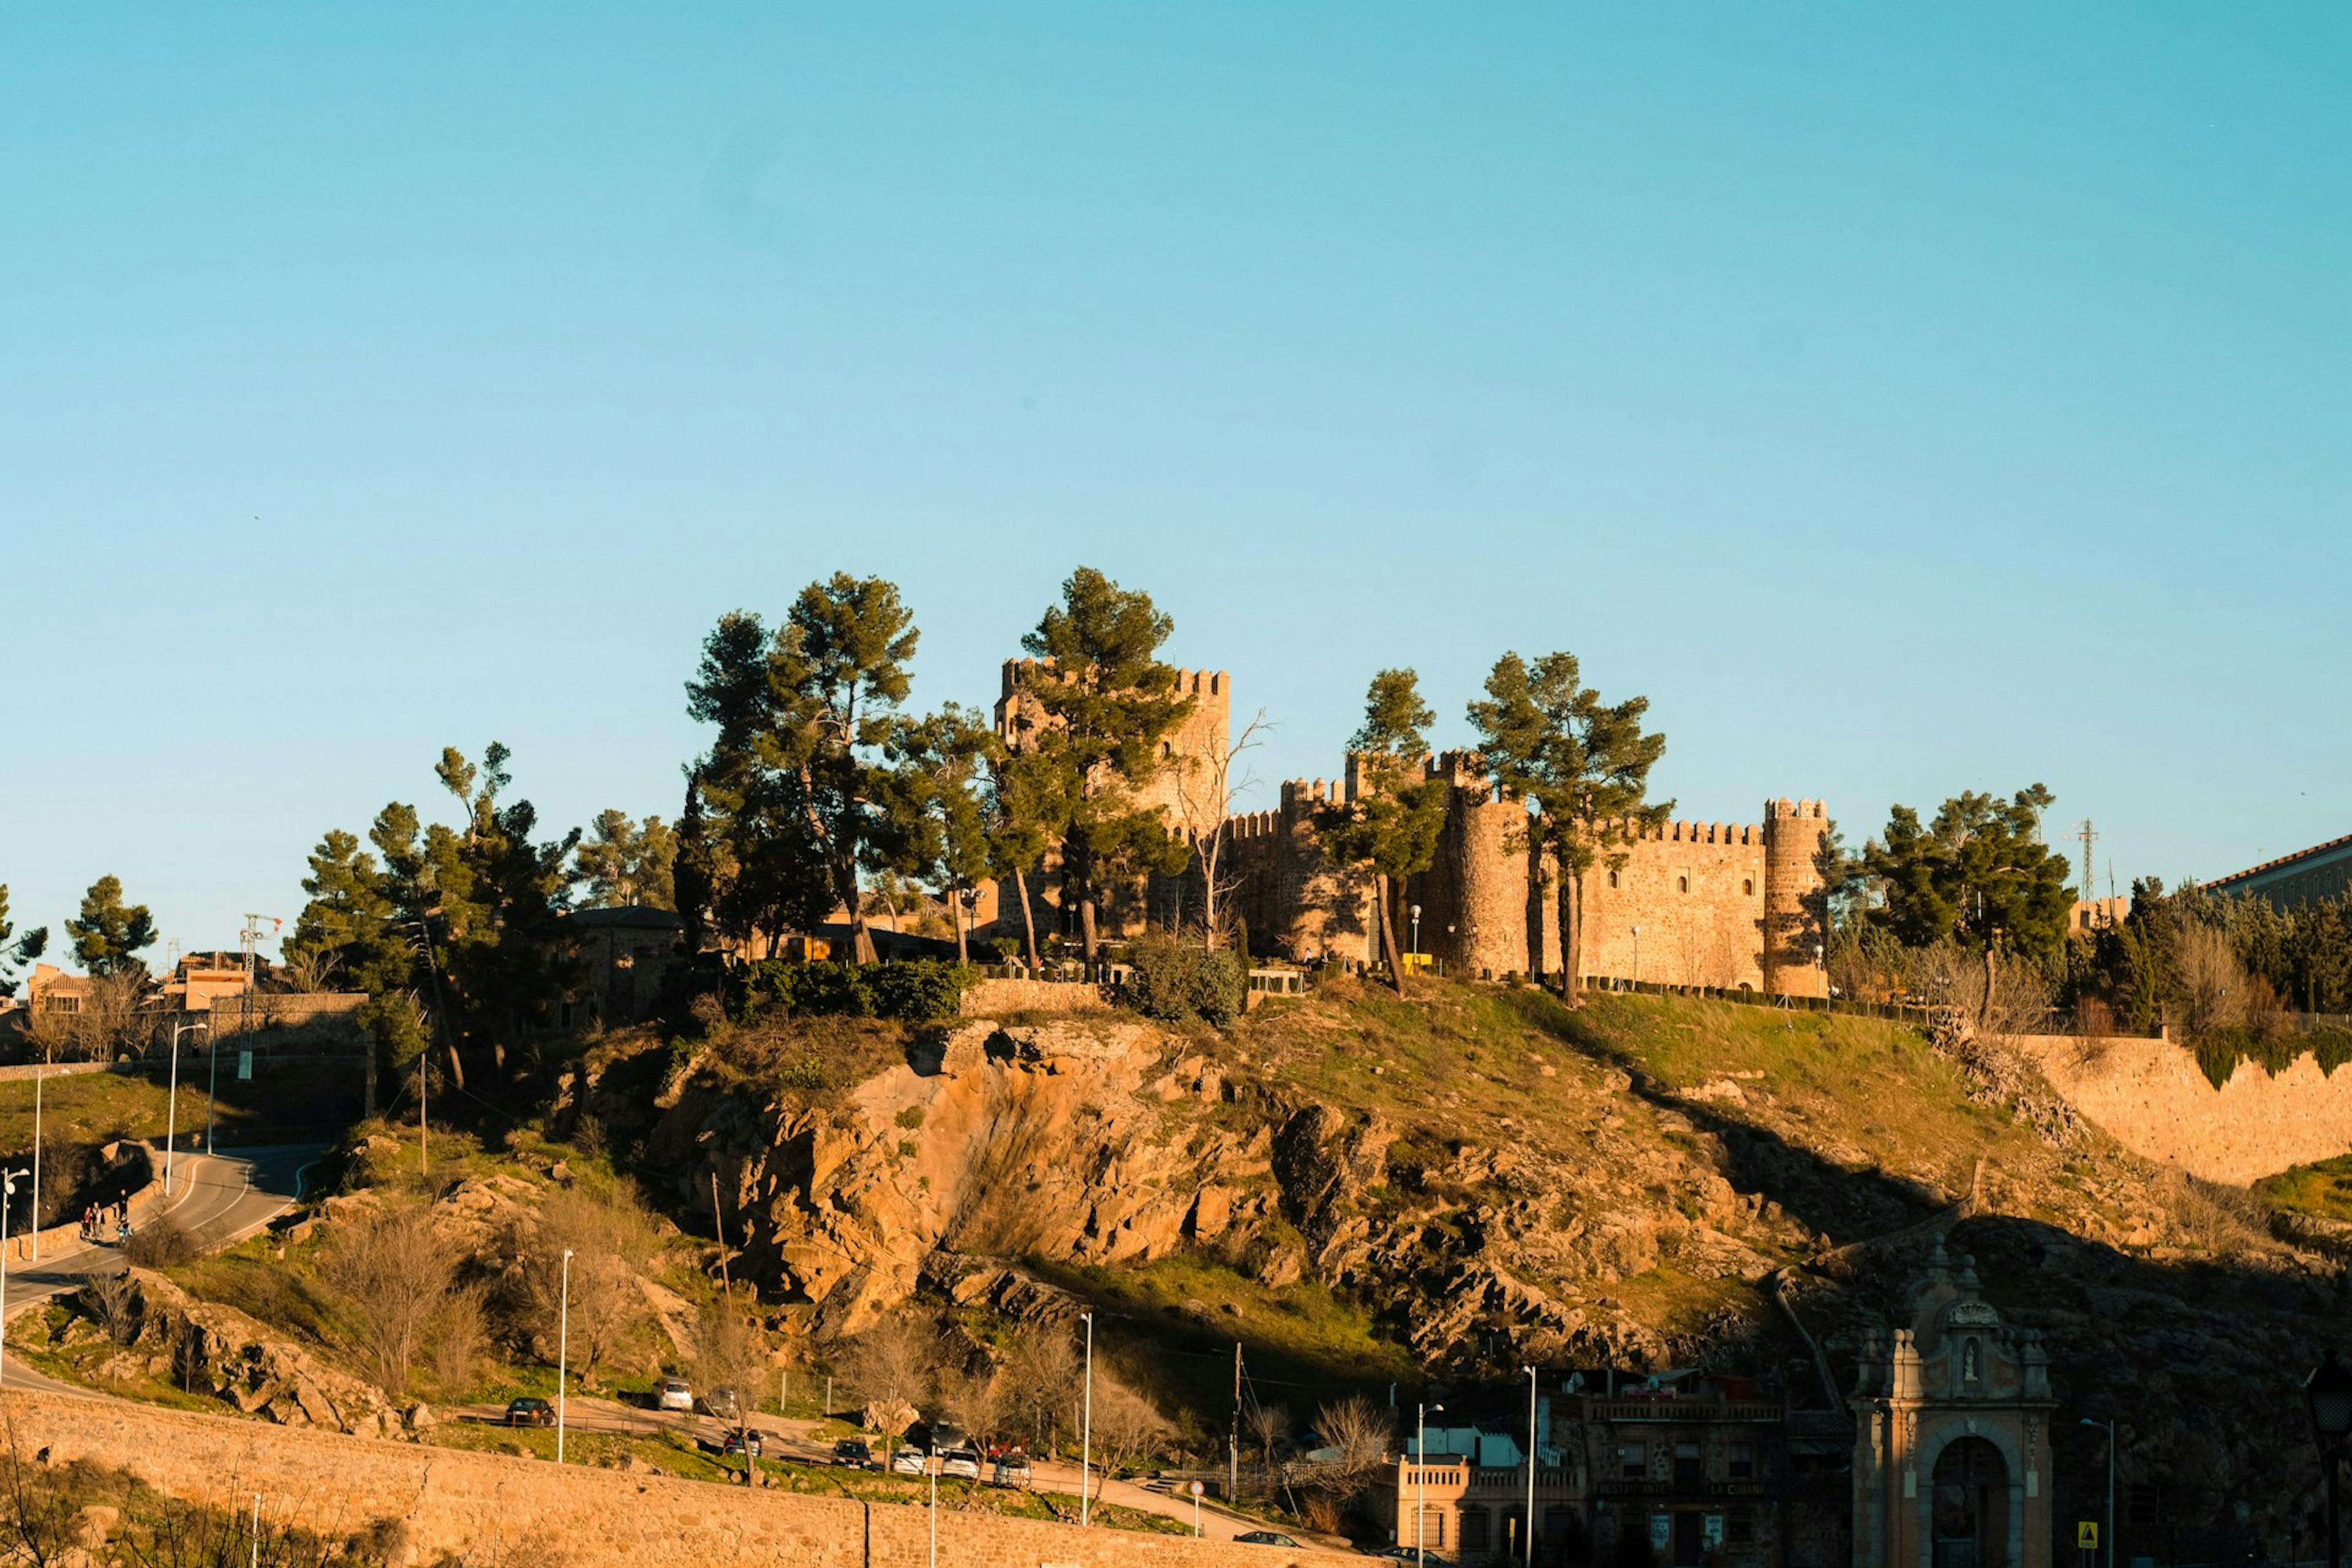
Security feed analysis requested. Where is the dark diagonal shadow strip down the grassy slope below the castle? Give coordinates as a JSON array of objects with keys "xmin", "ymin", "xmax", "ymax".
[{"xmin": 1512, "ymin": 992, "xmax": 1952, "ymax": 1246}]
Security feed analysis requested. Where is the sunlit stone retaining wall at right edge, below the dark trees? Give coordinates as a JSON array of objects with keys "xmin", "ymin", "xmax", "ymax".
[{"xmin": 2016, "ymin": 1035, "xmax": 2352, "ymax": 1183}]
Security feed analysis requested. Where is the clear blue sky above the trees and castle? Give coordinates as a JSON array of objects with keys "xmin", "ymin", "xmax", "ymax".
[{"xmin": 0, "ymin": 0, "xmax": 2352, "ymax": 959}]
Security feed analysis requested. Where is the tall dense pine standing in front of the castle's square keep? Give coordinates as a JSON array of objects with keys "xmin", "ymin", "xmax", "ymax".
[{"xmin": 1016, "ymin": 567, "xmax": 1193, "ymax": 964}]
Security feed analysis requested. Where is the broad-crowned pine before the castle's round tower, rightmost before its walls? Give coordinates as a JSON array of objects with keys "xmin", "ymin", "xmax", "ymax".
[{"xmin": 1470, "ymin": 654, "xmax": 1675, "ymax": 1006}]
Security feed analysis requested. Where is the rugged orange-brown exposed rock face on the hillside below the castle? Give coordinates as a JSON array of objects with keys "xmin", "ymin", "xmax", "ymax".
[{"xmin": 571, "ymin": 1020, "xmax": 1815, "ymax": 1361}]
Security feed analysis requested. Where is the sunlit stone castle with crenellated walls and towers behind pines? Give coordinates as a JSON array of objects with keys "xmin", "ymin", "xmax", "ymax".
[{"xmin": 976, "ymin": 661, "xmax": 1830, "ymax": 997}]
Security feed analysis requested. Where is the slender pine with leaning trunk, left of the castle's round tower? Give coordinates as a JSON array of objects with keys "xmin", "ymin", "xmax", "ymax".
[{"xmin": 1317, "ymin": 670, "xmax": 1449, "ymax": 992}]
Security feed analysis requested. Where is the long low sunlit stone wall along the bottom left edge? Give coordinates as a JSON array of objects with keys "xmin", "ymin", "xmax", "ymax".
[{"xmin": 0, "ymin": 1389, "xmax": 1341, "ymax": 1568}]
